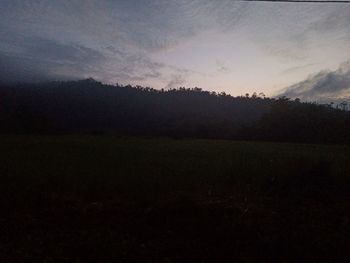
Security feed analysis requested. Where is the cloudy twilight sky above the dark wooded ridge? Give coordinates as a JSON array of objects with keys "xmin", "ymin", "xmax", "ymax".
[{"xmin": 0, "ymin": 0, "xmax": 350, "ymax": 101}]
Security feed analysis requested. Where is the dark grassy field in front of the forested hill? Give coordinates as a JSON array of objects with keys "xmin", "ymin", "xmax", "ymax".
[{"xmin": 0, "ymin": 136, "xmax": 350, "ymax": 262}]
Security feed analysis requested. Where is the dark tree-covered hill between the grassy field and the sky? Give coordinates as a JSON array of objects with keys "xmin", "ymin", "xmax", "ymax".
[{"xmin": 0, "ymin": 79, "xmax": 350, "ymax": 143}]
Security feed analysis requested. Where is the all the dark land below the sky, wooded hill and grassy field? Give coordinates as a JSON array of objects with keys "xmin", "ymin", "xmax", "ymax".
[{"xmin": 0, "ymin": 79, "xmax": 350, "ymax": 262}]
